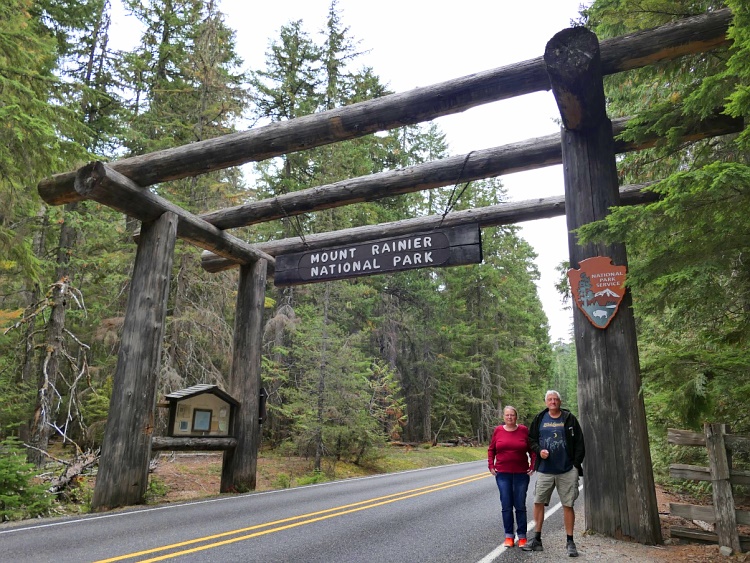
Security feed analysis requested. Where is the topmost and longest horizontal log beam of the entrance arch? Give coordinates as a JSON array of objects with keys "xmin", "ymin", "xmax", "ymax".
[{"xmin": 38, "ymin": 9, "xmax": 732, "ymax": 205}]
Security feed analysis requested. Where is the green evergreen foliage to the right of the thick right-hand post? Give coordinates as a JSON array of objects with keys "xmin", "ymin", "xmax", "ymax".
[{"xmin": 584, "ymin": 0, "xmax": 750, "ymax": 440}]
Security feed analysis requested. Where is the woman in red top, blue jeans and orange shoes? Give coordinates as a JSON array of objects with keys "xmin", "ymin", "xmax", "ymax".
[{"xmin": 487, "ymin": 405, "xmax": 536, "ymax": 547}]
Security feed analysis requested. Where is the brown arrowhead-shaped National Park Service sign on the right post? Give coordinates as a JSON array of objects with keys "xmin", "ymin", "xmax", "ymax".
[{"xmin": 568, "ymin": 256, "xmax": 627, "ymax": 329}]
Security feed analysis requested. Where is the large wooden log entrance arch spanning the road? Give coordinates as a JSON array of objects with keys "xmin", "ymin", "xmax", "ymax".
[{"xmin": 39, "ymin": 10, "xmax": 743, "ymax": 543}]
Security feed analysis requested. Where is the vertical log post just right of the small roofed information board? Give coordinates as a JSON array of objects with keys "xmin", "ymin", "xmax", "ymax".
[{"xmin": 220, "ymin": 260, "xmax": 267, "ymax": 493}]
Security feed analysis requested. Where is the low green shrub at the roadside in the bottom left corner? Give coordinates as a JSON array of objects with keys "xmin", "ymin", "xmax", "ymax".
[{"xmin": 0, "ymin": 438, "xmax": 54, "ymax": 522}]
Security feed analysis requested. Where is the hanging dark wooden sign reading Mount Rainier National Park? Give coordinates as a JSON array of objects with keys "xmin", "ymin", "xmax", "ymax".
[{"xmin": 274, "ymin": 224, "xmax": 482, "ymax": 286}]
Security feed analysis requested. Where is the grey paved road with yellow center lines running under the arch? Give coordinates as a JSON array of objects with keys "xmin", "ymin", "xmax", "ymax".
[{"xmin": 0, "ymin": 461, "xmax": 576, "ymax": 563}]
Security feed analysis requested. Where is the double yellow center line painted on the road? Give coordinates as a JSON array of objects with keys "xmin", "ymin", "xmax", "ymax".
[{"xmin": 95, "ymin": 472, "xmax": 489, "ymax": 563}]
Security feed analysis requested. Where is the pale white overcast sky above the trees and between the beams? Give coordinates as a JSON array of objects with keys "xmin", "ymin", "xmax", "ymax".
[{"xmin": 113, "ymin": 0, "xmax": 591, "ymax": 341}]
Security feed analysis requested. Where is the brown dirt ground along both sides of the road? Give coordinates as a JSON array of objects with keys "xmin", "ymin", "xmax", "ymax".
[{"xmin": 153, "ymin": 453, "xmax": 750, "ymax": 563}]
